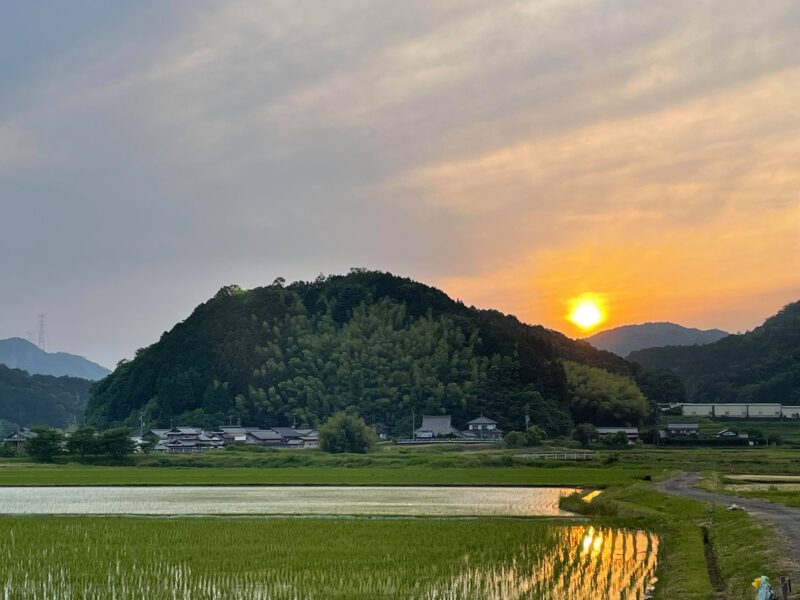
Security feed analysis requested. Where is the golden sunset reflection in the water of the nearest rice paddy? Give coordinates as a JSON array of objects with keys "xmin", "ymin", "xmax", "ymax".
[{"xmin": 444, "ymin": 526, "xmax": 658, "ymax": 600}]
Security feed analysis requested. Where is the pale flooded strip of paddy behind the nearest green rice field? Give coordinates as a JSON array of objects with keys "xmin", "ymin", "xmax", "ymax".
[{"xmin": 0, "ymin": 486, "xmax": 575, "ymax": 517}]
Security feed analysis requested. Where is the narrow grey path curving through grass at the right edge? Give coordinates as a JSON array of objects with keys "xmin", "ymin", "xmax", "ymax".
[{"xmin": 656, "ymin": 473, "xmax": 800, "ymax": 582}]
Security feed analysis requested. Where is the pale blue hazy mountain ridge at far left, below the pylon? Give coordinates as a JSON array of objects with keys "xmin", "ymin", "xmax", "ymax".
[{"xmin": 0, "ymin": 338, "xmax": 111, "ymax": 381}]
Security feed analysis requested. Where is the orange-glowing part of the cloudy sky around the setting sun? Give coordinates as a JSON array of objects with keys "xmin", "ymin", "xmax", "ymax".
[{"xmin": 428, "ymin": 69, "xmax": 800, "ymax": 337}]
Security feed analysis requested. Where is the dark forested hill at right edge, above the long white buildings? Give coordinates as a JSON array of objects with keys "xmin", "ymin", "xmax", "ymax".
[{"xmin": 629, "ymin": 302, "xmax": 800, "ymax": 404}]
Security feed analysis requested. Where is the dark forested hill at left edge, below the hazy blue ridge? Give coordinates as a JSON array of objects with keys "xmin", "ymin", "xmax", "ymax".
[{"xmin": 0, "ymin": 365, "xmax": 91, "ymax": 433}]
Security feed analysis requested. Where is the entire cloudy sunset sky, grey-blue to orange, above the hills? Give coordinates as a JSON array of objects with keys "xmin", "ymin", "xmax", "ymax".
[{"xmin": 0, "ymin": 0, "xmax": 800, "ymax": 366}]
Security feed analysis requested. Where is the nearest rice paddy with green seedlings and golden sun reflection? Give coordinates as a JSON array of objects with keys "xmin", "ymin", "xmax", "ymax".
[{"xmin": 0, "ymin": 516, "xmax": 659, "ymax": 600}]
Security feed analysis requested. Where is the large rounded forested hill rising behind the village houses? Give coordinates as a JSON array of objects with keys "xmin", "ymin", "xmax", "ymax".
[{"xmin": 87, "ymin": 270, "xmax": 631, "ymax": 433}]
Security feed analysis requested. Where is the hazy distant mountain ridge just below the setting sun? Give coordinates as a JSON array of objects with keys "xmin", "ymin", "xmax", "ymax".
[{"xmin": 586, "ymin": 322, "xmax": 729, "ymax": 356}]
